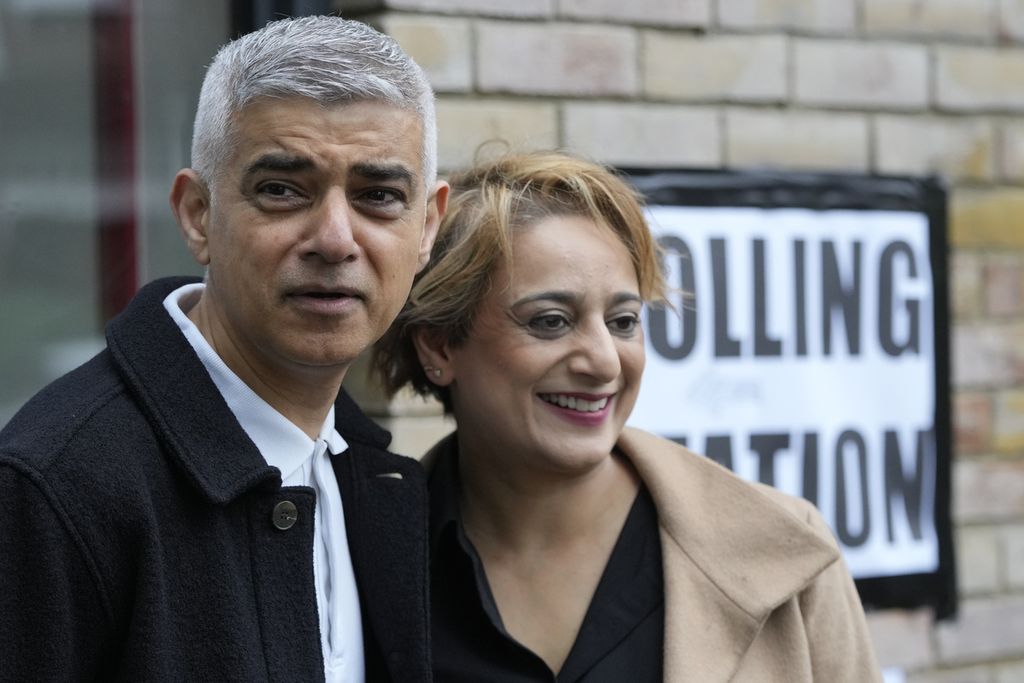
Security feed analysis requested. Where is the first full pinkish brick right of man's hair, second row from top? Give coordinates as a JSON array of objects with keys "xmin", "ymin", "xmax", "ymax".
[{"xmin": 477, "ymin": 22, "xmax": 638, "ymax": 95}]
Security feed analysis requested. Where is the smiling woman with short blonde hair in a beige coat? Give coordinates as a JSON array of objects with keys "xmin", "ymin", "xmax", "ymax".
[{"xmin": 374, "ymin": 153, "xmax": 881, "ymax": 683}]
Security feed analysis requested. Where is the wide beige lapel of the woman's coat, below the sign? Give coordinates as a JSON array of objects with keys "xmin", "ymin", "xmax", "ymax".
[{"xmin": 618, "ymin": 428, "xmax": 839, "ymax": 683}]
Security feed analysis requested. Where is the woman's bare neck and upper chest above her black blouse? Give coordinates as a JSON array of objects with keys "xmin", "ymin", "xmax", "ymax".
[{"xmin": 459, "ymin": 436, "xmax": 640, "ymax": 672}]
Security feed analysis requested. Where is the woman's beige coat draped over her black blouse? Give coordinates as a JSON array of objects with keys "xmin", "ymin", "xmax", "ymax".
[{"xmin": 618, "ymin": 428, "xmax": 882, "ymax": 683}]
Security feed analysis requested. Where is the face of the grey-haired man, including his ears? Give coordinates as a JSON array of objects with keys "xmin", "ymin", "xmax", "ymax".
[{"xmin": 172, "ymin": 98, "xmax": 446, "ymax": 383}]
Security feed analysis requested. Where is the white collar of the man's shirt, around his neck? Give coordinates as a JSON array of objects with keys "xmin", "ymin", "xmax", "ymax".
[{"xmin": 164, "ymin": 283, "xmax": 348, "ymax": 480}]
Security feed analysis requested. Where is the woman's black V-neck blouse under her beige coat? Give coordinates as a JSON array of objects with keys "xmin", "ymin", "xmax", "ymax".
[{"xmin": 430, "ymin": 439, "xmax": 665, "ymax": 683}]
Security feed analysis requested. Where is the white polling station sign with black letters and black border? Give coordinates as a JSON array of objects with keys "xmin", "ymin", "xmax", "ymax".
[{"xmin": 629, "ymin": 170, "xmax": 955, "ymax": 615}]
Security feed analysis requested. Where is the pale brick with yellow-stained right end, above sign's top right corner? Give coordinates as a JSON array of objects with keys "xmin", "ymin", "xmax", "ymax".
[{"xmin": 874, "ymin": 116, "xmax": 995, "ymax": 180}]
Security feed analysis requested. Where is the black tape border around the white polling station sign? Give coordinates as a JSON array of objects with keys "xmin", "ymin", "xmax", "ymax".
[{"xmin": 616, "ymin": 167, "xmax": 957, "ymax": 620}]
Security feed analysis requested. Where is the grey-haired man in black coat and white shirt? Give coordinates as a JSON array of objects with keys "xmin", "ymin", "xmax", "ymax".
[{"xmin": 0, "ymin": 17, "xmax": 447, "ymax": 683}]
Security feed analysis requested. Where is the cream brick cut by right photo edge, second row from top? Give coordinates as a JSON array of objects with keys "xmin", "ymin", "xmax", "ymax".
[{"xmin": 935, "ymin": 46, "xmax": 1024, "ymax": 112}]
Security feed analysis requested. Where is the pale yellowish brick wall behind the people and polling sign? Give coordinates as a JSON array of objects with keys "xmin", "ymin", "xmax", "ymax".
[{"xmin": 339, "ymin": 0, "xmax": 1024, "ymax": 683}]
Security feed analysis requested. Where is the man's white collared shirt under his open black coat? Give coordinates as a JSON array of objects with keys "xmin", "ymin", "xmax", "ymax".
[{"xmin": 164, "ymin": 283, "xmax": 366, "ymax": 683}]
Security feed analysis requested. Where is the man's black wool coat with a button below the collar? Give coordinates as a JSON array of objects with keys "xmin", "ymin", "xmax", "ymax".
[{"xmin": 0, "ymin": 279, "xmax": 430, "ymax": 683}]
